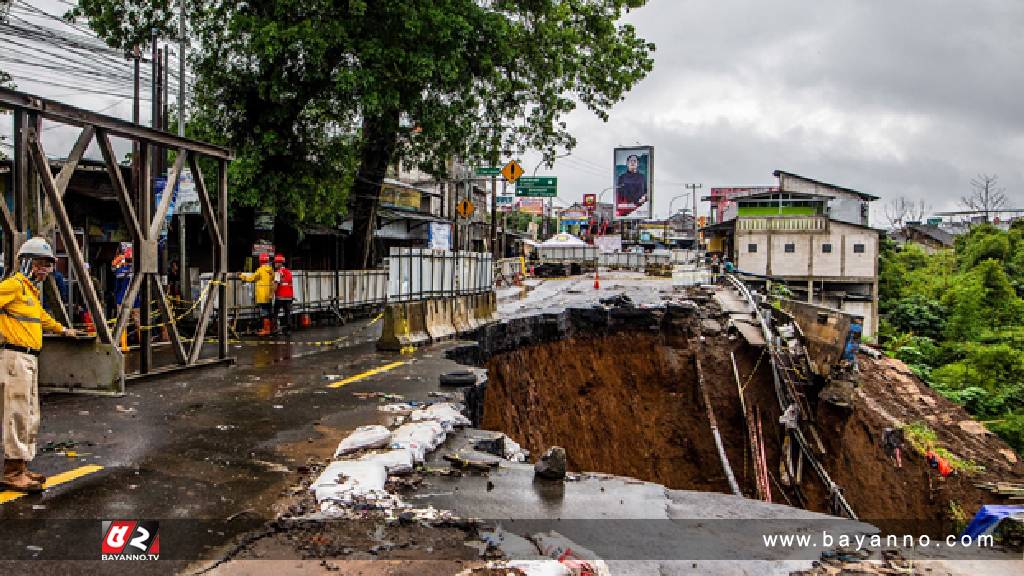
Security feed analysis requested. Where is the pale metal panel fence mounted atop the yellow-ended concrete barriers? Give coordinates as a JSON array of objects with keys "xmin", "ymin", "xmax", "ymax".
[{"xmin": 387, "ymin": 248, "xmax": 495, "ymax": 302}]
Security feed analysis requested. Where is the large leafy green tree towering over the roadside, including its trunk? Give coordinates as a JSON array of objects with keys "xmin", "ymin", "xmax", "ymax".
[{"xmin": 70, "ymin": 0, "xmax": 653, "ymax": 268}]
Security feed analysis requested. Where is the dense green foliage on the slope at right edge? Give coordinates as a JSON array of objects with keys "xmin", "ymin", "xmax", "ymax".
[{"xmin": 879, "ymin": 222, "xmax": 1024, "ymax": 451}]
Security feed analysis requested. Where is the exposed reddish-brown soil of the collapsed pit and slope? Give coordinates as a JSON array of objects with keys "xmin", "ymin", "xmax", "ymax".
[{"xmin": 482, "ymin": 325, "xmax": 1024, "ymax": 533}]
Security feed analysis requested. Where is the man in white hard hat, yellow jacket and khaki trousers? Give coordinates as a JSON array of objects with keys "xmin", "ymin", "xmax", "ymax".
[{"xmin": 0, "ymin": 238, "xmax": 77, "ymax": 492}]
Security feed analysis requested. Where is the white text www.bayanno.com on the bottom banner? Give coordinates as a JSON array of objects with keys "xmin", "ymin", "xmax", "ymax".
[{"xmin": 761, "ymin": 531, "xmax": 993, "ymax": 550}]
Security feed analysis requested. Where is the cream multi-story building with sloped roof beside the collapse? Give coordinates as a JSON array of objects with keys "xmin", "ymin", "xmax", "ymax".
[{"xmin": 703, "ymin": 171, "xmax": 881, "ymax": 335}]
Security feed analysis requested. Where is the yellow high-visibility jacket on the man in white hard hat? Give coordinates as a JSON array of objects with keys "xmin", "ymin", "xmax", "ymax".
[{"xmin": 0, "ymin": 273, "xmax": 65, "ymax": 349}]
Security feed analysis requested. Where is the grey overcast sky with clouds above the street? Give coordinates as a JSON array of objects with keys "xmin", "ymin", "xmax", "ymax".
[{"xmin": 5, "ymin": 0, "xmax": 1024, "ymax": 225}]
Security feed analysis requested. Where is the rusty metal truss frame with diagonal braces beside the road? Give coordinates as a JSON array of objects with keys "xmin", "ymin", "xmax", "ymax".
[{"xmin": 0, "ymin": 87, "xmax": 232, "ymax": 375}]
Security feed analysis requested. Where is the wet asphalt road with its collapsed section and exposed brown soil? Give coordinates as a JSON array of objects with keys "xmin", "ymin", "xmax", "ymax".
[{"xmin": 0, "ymin": 274, "xmax": 1024, "ymax": 574}]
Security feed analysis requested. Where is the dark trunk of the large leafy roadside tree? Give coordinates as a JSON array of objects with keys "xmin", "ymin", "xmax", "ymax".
[{"xmin": 345, "ymin": 111, "xmax": 398, "ymax": 270}]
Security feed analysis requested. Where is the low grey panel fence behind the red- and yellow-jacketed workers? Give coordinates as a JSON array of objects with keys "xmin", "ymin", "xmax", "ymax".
[{"xmin": 200, "ymin": 270, "xmax": 388, "ymax": 319}]
